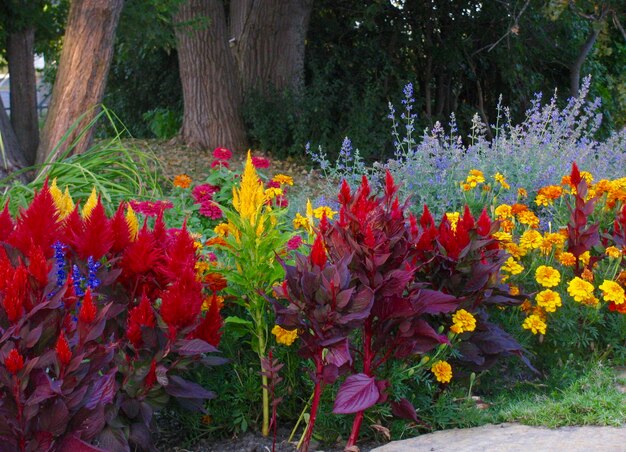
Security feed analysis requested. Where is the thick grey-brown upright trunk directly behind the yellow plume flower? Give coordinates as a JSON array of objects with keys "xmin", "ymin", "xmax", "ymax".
[{"xmin": 174, "ymin": 0, "xmax": 246, "ymax": 150}]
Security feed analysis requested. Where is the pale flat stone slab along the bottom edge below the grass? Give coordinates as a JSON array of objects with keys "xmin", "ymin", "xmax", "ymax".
[{"xmin": 371, "ymin": 424, "xmax": 626, "ymax": 452}]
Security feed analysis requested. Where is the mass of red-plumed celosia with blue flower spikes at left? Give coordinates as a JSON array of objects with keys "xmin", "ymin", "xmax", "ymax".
[{"xmin": 0, "ymin": 183, "xmax": 221, "ymax": 451}]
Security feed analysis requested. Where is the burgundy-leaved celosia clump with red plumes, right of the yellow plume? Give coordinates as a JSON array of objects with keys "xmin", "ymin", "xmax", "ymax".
[{"xmin": 273, "ymin": 173, "xmax": 522, "ymax": 450}]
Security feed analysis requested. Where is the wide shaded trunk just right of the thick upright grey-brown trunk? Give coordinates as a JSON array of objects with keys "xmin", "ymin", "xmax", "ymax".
[{"xmin": 230, "ymin": 0, "xmax": 313, "ymax": 93}]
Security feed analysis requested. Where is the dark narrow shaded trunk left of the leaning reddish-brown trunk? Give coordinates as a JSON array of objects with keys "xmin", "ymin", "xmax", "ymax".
[{"xmin": 7, "ymin": 27, "xmax": 39, "ymax": 165}]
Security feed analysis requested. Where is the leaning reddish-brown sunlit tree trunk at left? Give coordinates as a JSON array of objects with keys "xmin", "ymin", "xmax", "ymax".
[{"xmin": 37, "ymin": 0, "xmax": 124, "ymax": 164}]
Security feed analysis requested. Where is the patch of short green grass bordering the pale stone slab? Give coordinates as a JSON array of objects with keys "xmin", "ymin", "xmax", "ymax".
[{"xmin": 489, "ymin": 362, "xmax": 626, "ymax": 428}]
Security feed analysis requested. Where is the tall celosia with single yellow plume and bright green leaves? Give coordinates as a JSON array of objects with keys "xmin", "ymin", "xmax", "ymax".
[{"xmin": 216, "ymin": 152, "xmax": 290, "ymax": 436}]
